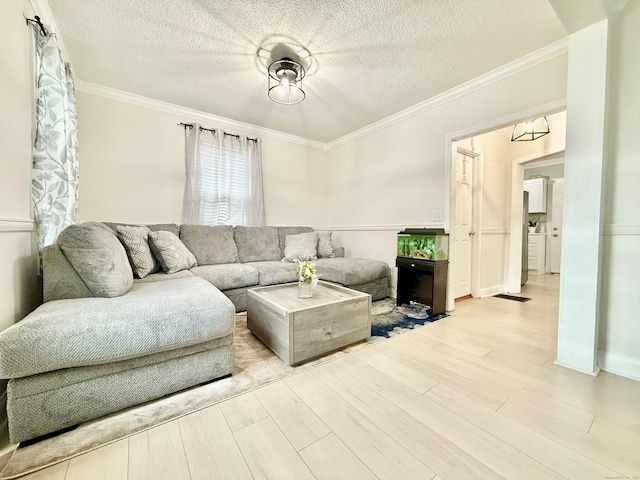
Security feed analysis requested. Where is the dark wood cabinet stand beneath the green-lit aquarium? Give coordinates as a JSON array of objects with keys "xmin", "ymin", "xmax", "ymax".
[{"xmin": 396, "ymin": 257, "xmax": 449, "ymax": 315}]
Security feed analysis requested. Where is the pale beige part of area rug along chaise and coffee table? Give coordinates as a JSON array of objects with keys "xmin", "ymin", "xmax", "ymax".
[{"xmin": 0, "ymin": 306, "xmax": 400, "ymax": 479}]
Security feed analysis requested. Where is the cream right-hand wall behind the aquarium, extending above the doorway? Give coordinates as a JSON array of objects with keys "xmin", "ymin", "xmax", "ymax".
[{"xmin": 327, "ymin": 55, "xmax": 567, "ymax": 298}]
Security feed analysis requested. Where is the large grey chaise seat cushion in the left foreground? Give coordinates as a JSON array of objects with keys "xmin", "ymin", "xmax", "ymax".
[{"xmin": 0, "ymin": 277, "xmax": 235, "ymax": 378}]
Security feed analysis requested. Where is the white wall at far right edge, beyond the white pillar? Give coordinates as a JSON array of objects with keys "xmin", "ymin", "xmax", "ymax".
[{"xmin": 598, "ymin": 2, "xmax": 640, "ymax": 380}]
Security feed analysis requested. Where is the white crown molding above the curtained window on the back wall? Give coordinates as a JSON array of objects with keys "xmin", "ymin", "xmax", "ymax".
[{"xmin": 75, "ymin": 80, "xmax": 325, "ymax": 150}]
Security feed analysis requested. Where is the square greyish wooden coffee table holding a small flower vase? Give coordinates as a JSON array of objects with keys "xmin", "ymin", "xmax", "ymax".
[{"xmin": 247, "ymin": 282, "xmax": 371, "ymax": 365}]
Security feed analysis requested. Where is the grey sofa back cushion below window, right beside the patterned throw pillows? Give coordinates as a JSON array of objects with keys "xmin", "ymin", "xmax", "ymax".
[{"xmin": 180, "ymin": 225, "xmax": 238, "ymax": 265}]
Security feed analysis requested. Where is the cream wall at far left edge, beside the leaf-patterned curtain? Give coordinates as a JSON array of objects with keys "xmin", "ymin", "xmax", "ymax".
[{"xmin": 0, "ymin": 0, "xmax": 41, "ymax": 453}]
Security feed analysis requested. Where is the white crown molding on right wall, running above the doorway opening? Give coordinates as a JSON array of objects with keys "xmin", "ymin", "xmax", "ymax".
[{"xmin": 325, "ymin": 37, "xmax": 569, "ymax": 150}]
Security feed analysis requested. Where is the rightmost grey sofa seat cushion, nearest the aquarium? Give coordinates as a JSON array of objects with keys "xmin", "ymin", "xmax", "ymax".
[{"xmin": 315, "ymin": 257, "xmax": 389, "ymax": 286}]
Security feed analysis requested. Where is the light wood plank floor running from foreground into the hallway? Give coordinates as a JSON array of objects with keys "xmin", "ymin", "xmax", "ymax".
[{"xmin": 24, "ymin": 275, "xmax": 640, "ymax": 480}]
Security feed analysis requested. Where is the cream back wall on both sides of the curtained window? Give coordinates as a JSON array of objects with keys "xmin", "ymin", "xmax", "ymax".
[{"xmin": 77, "ymin": 92, "xmax": 326, "ymax": 229}]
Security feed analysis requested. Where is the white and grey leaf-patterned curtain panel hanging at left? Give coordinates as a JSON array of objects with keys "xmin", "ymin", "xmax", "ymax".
[{"xmin": 31, "ymin": 27, "xmax": 78, "ymax": 250}]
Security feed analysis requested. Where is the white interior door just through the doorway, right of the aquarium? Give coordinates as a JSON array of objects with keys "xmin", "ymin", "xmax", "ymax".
[{"xmin": 453, "ymin": 152, "xmax": 474, "ymax": 298}]
